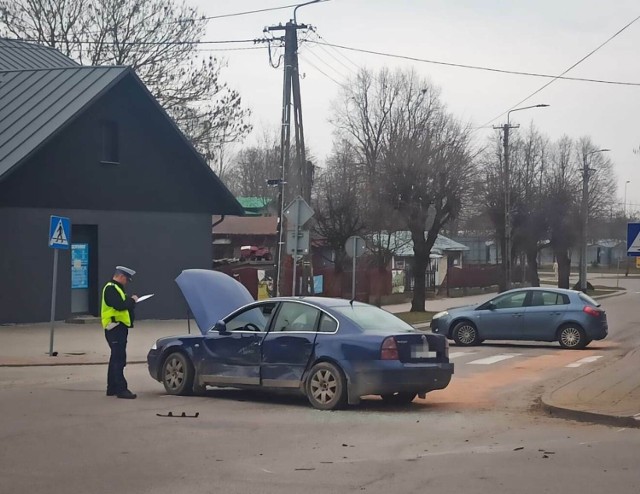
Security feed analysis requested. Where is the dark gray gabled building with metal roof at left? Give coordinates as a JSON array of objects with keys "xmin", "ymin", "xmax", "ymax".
[{"xmin": 0, "ymin": 39, "xmax": 243, "ymax": 324}]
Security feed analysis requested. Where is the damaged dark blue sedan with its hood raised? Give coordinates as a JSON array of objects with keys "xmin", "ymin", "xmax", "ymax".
[{"xmin": 147, "ymin": 269, "xmax": 453, "ymax": 410}]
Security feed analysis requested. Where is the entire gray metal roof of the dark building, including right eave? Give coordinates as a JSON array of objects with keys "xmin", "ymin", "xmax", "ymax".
[{"xmin": 0, "ymin": 38, "xmax": 244, "ymax": 216}]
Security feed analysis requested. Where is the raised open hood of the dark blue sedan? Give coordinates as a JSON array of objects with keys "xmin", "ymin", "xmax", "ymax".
[{"xmin": 176, "ymin": 269, "xmax": 255, "ymax": 334}]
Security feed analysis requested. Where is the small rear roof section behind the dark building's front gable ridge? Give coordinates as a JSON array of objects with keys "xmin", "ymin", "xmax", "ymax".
[{"xmin": 0, "ymin": 38, "xmax": 78, "ymax": 71}]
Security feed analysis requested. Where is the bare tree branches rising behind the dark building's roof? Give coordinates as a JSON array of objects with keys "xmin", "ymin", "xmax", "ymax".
[{"xmin": 0, "ymin": 0, "xmax": 251, "ymax": 160}]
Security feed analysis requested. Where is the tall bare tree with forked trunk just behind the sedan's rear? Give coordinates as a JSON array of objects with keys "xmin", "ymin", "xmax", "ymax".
[{"xmin": 379, "ymin": 72, "xmax": 473, "ymax": 311}]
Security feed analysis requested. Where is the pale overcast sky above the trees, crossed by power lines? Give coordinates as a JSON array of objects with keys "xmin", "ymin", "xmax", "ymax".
[{"xmin": 194, "ymin": 0, "xmax": 640, "ymax": 212}]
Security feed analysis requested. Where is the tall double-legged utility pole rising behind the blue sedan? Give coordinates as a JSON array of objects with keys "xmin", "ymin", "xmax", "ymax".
[{"xmin": 265, "ymin": 0, "xmax": 319, "ymax": 296}]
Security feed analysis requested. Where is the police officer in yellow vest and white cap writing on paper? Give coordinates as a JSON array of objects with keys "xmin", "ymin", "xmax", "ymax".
[{"xmin": 100, "ymin": 266, "xmax": 138, "ymax": 400}]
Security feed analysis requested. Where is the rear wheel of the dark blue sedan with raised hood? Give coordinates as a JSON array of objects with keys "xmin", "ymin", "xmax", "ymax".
[{"xmin": 306, "ymin": 362, "xmax": 347, "ymax": 410}]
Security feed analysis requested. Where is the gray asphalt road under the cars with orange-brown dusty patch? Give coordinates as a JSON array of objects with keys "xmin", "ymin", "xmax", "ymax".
[{"xmin": 0, "ymin": 280, "xmax": 640, "ymax": 494}]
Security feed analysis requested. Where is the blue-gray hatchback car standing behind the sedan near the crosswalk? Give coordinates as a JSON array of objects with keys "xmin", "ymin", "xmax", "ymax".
[{"xmin": 431, "ymin": 288, "xmax": 609, "ymax": 349}]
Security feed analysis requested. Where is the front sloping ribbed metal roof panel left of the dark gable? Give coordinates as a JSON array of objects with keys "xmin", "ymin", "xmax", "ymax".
[{"xmin": 0, "ymin": 66, "xmax": 131, "ymax": 181}]
